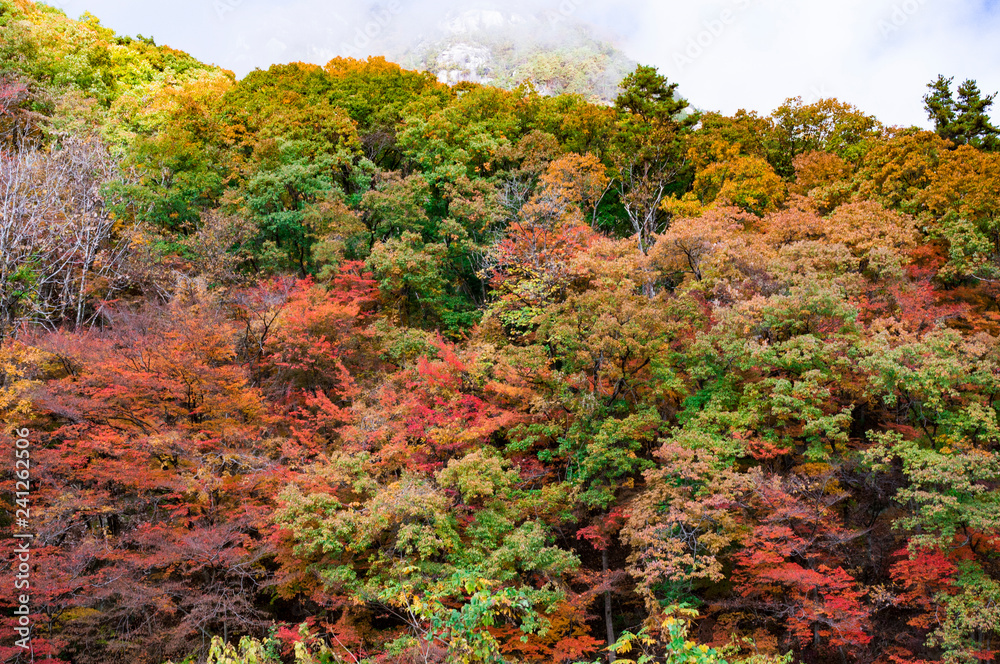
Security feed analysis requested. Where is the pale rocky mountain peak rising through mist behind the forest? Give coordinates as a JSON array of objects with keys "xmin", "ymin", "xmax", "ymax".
[{"xmin": 390, "ymin": 5, "xmax": 635, "ymax": 101}]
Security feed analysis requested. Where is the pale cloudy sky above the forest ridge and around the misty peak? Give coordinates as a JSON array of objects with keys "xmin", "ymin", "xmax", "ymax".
[{"xmin": 48, "ymin": 0, "xmax": 1000, "ymax": 126}]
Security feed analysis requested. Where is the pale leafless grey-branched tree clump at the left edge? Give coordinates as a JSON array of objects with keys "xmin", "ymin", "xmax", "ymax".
[{"xmin": 0, "ymin": 137, "xmax": 130, "ymax": 341}]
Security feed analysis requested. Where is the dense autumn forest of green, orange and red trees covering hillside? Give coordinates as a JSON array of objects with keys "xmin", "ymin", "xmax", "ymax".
[{"xmin": 0, "ymin": 0, "xmax": 1000, "ymax": 664}]
